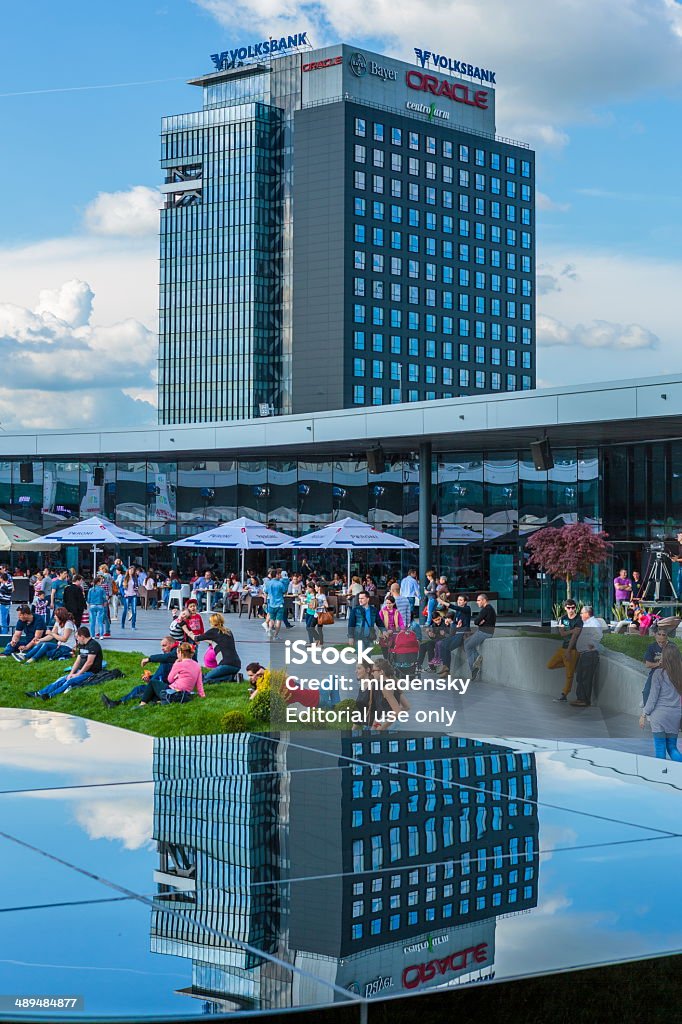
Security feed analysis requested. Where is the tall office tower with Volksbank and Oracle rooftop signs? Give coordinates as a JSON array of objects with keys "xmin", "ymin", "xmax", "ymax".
[{"xmin": 159, "ymin": 34, "xmax": 536, "ymax": 424}]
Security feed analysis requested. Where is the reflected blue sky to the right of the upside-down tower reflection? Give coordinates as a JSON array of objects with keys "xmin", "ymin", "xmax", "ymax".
[{"xmin": 496, "ymin": 748, "xmax": 682, "ymax": 979}]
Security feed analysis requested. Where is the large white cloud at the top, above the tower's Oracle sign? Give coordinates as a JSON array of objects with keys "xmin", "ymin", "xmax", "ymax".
[{"xmin": 195, "ymin": 0, "xmax": 682, "ymax": 136}]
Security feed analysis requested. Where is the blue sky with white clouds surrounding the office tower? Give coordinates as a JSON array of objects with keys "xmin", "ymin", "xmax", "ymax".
[{"xmin": 0, "ymin": 0, "xmax": 682, "ymax": 429}]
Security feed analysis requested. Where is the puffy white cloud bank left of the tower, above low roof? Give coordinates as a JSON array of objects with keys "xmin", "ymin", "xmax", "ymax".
[{"xmin": 0, "ymin": 280, "xmax": 157, "ymax": 429}]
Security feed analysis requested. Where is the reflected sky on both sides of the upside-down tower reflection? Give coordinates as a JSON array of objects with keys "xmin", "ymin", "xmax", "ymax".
[{"xmin": 0, "ymin": 711, "xmax": 682, "ymax": 1016}]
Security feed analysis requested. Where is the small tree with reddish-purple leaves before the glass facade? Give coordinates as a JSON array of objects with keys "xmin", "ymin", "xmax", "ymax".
[{"xmin": 525, "ymin": 522, "xmax": 611, "ymax": 598}]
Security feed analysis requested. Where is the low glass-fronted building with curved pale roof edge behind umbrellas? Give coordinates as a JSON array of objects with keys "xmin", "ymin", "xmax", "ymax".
[{"xmin": 0, "ymin": 375, "xmax": 682, "ymax": 614}]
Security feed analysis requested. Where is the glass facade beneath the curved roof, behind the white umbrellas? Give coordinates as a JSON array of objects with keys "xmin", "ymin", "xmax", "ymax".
[{"xmin": 6, "ymin": 441, "xmax": 682, "ymax": 614}]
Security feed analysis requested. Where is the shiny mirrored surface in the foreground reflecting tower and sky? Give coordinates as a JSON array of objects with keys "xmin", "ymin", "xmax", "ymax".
[{"xmin": 0, "ymin": 711, "xmax": 682, "ymax": 1019}]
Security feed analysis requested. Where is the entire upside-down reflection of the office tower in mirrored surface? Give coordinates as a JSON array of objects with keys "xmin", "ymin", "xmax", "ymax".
[{"xmin": 152, "ymin": 733, "xmax": 538, "ymax": 1012}]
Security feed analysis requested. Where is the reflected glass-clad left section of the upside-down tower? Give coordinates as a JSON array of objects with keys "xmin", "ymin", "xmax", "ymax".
[{"xmin": 152, "ymin": 734, "xmax": 288, "ymax": 1011}]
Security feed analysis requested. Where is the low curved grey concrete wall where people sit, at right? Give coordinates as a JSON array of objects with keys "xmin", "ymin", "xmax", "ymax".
[{"xmin": 451, "ymin": 633, "xmax": 647, "ymax": 715}]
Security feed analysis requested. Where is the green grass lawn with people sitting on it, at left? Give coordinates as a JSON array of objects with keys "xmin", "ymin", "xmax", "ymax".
[{"xmin": 0, "ymin": 650, "xmax": 258, "ymax": 736}]
